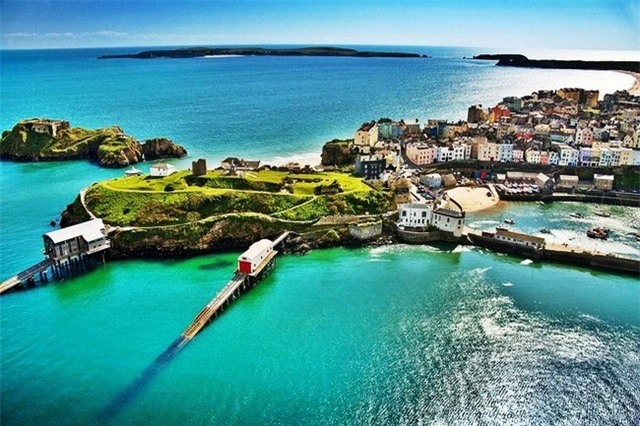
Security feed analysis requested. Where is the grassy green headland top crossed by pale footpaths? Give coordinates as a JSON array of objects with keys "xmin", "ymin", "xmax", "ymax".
[{"xmin": 86, "ymin": 170, "xmax": 388, "ymax": 226}]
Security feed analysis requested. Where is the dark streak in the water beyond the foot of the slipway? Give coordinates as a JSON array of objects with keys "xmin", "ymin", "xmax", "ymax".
[{"xmin": 98, "ymin": 336, "xmax": 188, "ymax": 423}]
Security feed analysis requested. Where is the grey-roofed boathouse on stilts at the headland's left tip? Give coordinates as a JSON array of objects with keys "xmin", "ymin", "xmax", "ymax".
[{"xmin": 42, "ymin": 219, "xmax": 111, "ymax": 266}]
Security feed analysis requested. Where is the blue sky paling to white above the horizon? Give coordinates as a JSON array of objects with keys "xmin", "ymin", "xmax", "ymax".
[{"xmin": 0, "ymin": 0, "xmax": 640, "ymax": 51}]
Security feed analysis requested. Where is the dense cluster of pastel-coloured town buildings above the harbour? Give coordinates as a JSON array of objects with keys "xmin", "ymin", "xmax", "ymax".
[{"xmin": 353, "ymin": 88, "xmax": 640, "ymax": 191}]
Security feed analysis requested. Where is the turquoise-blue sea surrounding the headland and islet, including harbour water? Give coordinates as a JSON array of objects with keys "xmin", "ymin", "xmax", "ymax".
[{"xmin": 0, "ymin": 47, "xmax": 640, "ymax": 425}]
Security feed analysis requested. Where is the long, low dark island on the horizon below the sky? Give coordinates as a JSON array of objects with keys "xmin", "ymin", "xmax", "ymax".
[{"xmin": 98, "ymin": 47, "xmax": 427, "ymax": 59}]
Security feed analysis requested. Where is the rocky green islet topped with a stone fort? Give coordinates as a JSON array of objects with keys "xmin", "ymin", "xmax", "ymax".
[{"xmin": 0, "ymin": 118, "xmax": 187, "ymax": 167}]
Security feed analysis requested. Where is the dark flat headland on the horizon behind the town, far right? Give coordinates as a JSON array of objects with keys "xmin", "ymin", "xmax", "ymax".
[{"xmin": 473, "ymin": 54, "xmax": 640, "ymax": 73}]
